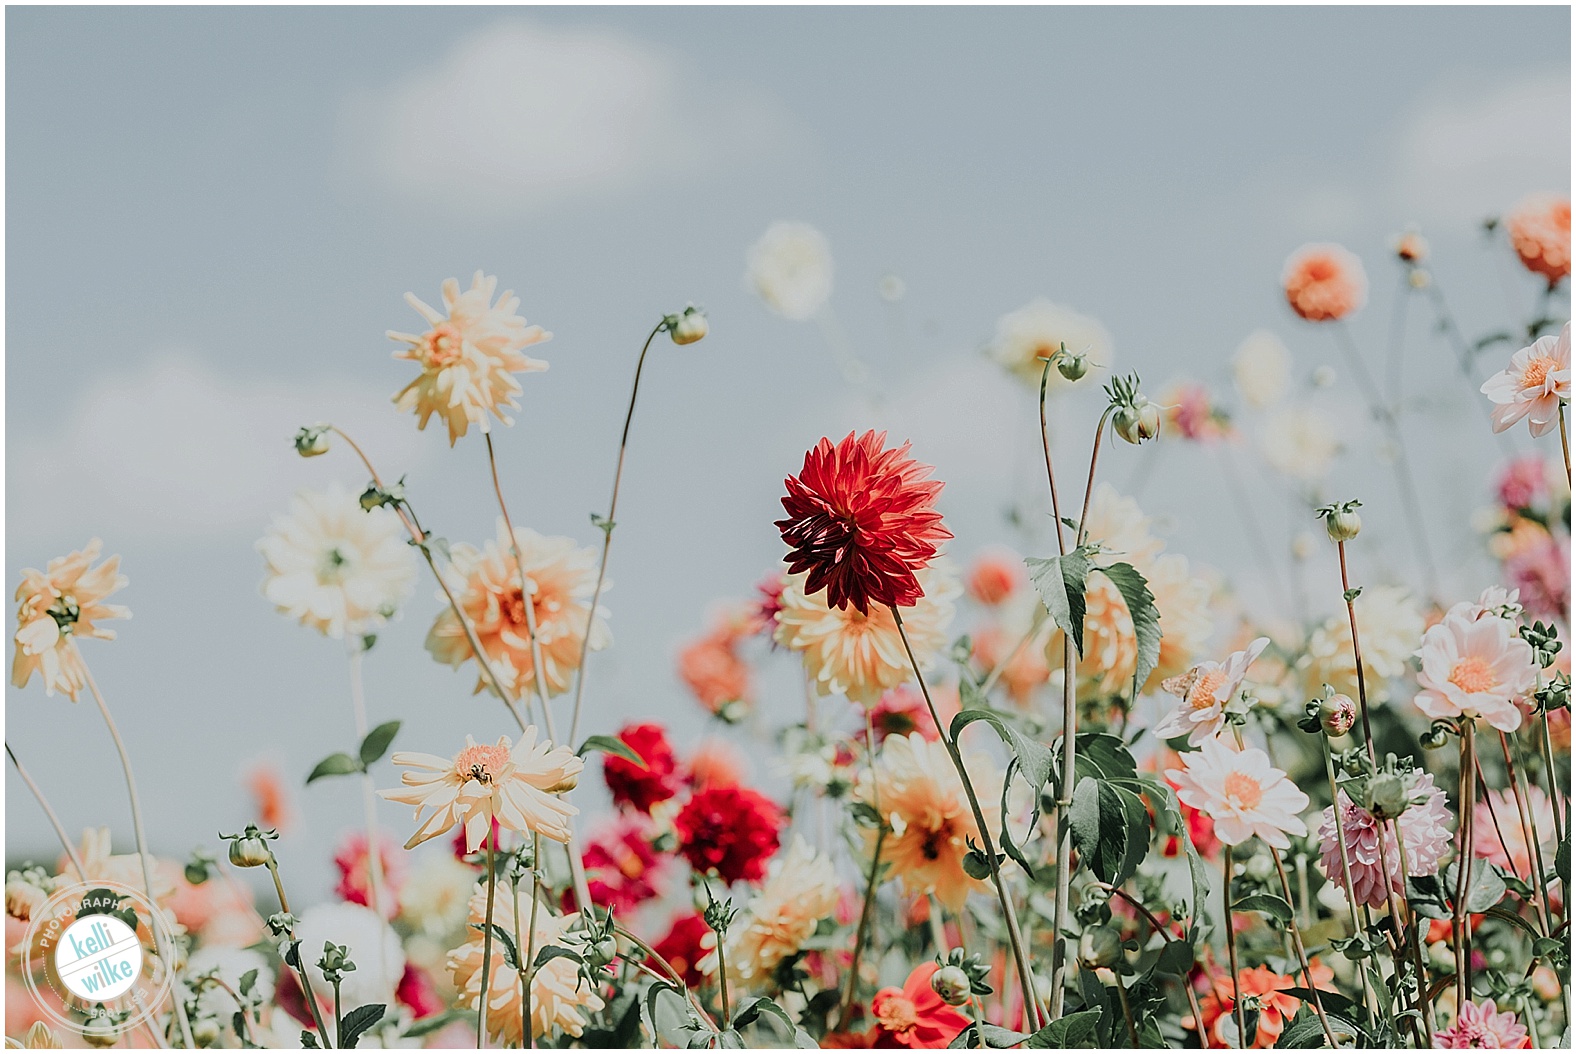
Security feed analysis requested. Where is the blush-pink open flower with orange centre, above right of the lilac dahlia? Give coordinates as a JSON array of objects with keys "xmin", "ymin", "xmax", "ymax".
[{"xmin": 1414, "ymin": 613, "xmax": 1538, "ymax": 733}]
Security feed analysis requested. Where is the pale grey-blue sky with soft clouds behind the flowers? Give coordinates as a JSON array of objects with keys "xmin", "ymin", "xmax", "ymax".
[{"xmin": 5, "ymin": 6, "xmax": 1570, "ymax": 901}]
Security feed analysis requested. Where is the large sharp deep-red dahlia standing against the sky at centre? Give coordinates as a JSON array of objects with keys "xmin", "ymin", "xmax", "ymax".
[{"xmin": 777, "ymin": 432, "xmax": 952, "ymax": 614}]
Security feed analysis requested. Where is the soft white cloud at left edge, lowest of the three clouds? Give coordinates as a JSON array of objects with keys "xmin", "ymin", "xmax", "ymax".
[{"xmin": 6, "ymin": 356, "xmax": 432, "ymax": 551}]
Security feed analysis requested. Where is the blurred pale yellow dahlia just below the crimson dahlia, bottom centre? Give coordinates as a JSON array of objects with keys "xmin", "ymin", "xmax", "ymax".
[{"xmin": 700, "ymin": 837, "xmax": 838, "ymax": 988}]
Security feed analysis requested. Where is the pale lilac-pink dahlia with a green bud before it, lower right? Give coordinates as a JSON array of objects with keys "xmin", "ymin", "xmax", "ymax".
[{"xmin": 1319, "ymin": 772, "xmax": 1450, "ymax": 907}]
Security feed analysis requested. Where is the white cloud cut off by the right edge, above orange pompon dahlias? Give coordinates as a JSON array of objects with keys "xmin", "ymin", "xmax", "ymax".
[{"xmin": 1396, "ymin": 69, "xmax": 1571, "ymax": 224}]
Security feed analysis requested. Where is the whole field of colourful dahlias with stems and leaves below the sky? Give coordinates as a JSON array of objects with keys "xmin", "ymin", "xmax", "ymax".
[{"xmin": 6, "ymin": 152, "xmax": 1571, "ymax": 1048}]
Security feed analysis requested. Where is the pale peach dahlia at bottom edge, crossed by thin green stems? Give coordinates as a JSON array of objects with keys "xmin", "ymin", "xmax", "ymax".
[{"xmin": 449, "ymin": 889, "xmax": 605, "ymax": 1046}]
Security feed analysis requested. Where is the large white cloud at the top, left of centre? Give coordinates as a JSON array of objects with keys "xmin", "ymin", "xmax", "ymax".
[{"xmin": 344, "ymin": 19, "xmax": 802, "ymax": 214}]
